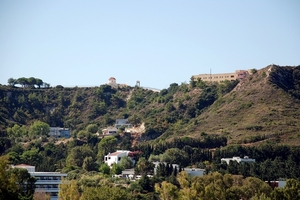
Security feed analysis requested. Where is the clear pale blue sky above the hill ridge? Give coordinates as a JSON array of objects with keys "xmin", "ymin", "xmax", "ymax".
[{"xmin": 0, "ymin": 0, "xmax": 300, "ymax": 89}]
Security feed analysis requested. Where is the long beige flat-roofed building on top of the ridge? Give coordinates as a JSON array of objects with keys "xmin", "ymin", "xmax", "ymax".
[{"xmin": 193, "ymin": 70, "xmax": 249, "ymax": 82}]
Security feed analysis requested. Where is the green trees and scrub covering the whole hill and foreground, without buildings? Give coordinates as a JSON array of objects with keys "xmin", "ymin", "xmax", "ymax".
[{"xmin": 0, "ymin": 66, "xmax": 300, "ymax": 199}]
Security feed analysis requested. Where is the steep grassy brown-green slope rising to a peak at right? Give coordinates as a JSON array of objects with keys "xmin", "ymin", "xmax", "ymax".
[{"xmin": 183, "ymin": 65, "xmax": 300, "ymax": 145}]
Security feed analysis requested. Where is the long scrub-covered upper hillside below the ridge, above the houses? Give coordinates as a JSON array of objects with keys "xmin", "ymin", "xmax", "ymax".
[{"xmin": 0, "ymin": 65, "xmax": 300, "ymax": 145}]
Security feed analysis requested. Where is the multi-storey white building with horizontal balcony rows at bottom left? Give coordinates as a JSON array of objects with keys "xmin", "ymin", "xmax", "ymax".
[{"xmin": 12, "ymin": 164, "xmax": 67, "ymax": 200}]
